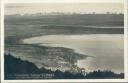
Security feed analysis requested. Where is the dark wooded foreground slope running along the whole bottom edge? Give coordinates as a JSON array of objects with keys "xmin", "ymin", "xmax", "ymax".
[{"xmin": 4, "ymin": 54, "xmax": 124, "ymax": 80}]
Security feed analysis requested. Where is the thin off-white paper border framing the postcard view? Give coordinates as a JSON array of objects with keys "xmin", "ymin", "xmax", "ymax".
[{"xmin": 0, "ymin": 0, "xmax": 128, "ymax": 83}]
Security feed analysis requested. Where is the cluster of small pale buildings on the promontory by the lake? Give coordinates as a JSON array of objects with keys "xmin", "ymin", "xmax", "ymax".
[{"xmin": 42, "ymin": 58, "xmax": 86, "ymax": 75}]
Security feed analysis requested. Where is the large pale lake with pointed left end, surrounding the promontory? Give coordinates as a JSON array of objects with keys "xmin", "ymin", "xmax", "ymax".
[{"xmin": 23, "ymin": 34, "xmax": 124, "ymax": 72}]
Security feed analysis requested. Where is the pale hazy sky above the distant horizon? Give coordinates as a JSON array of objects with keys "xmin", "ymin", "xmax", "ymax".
[{"xmin": 5, "ymin": 3, "xmax": 123, "ymax": 14}]
